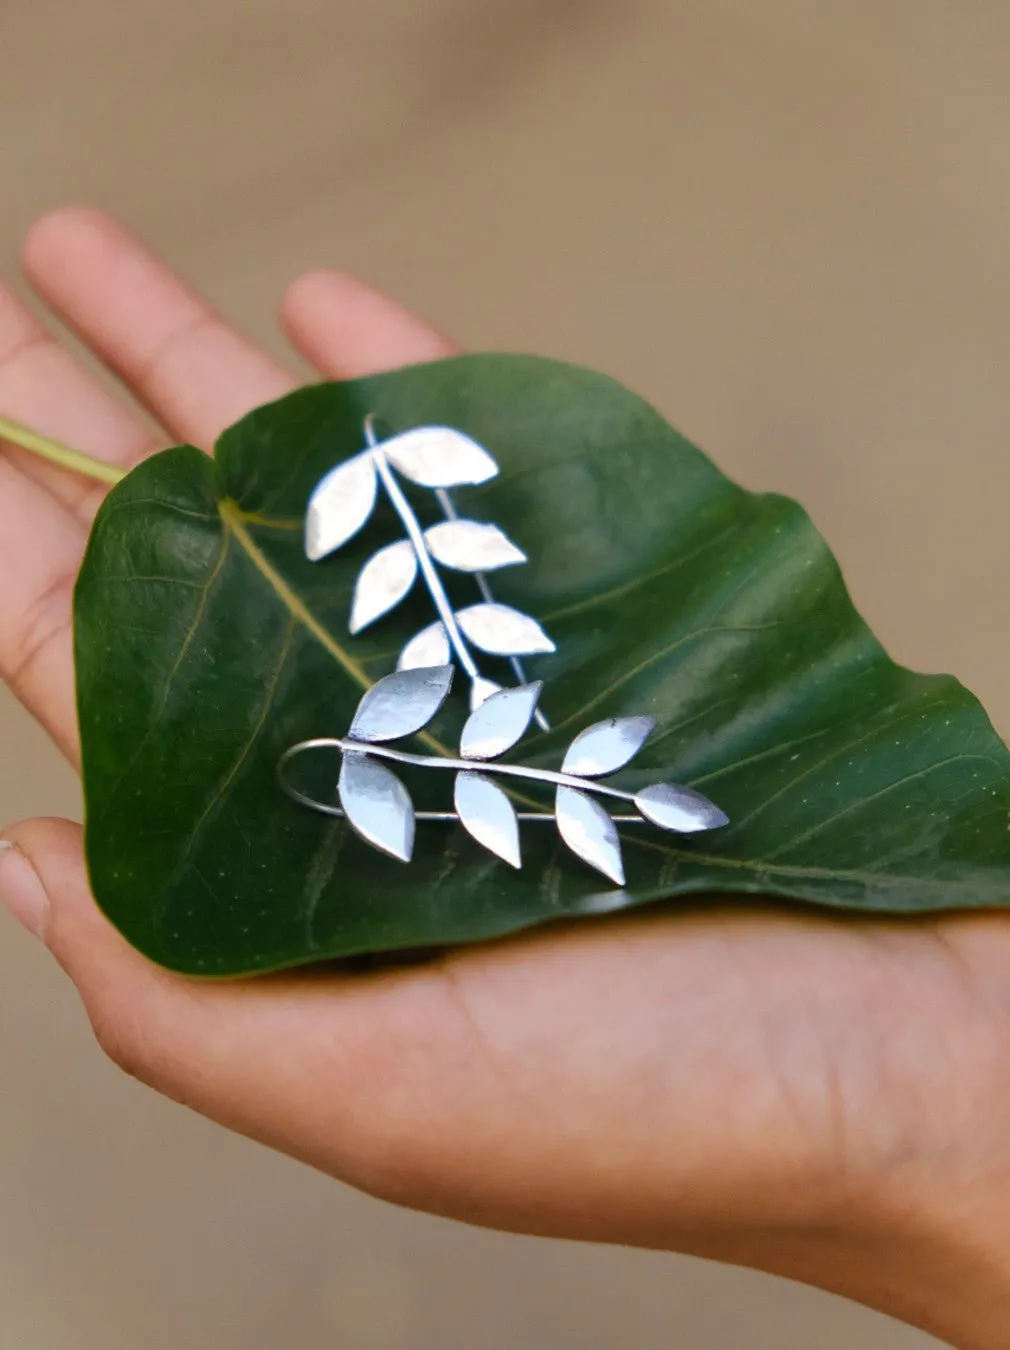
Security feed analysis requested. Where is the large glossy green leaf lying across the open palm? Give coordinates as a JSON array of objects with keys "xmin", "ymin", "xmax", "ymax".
[{"xmin": 76, "ymin": 356, "xmax": 1010, "ymax": 975}]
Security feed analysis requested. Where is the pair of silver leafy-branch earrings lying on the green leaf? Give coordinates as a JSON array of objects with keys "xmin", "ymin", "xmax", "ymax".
[{"xmin": 280, "ymin": 416, "xmax": 728, "ymax": 886}]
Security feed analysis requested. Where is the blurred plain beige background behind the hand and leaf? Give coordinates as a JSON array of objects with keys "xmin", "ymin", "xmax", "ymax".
[{"xmin": 0, "ymin": 0, "xmax": 1010, "ymax": 1350}]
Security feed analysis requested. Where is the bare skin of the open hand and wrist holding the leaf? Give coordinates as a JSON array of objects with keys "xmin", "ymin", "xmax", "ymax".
[{"xmin": 0, "ymin": 209, "xmax": 1010, "ymax": 1350}]
